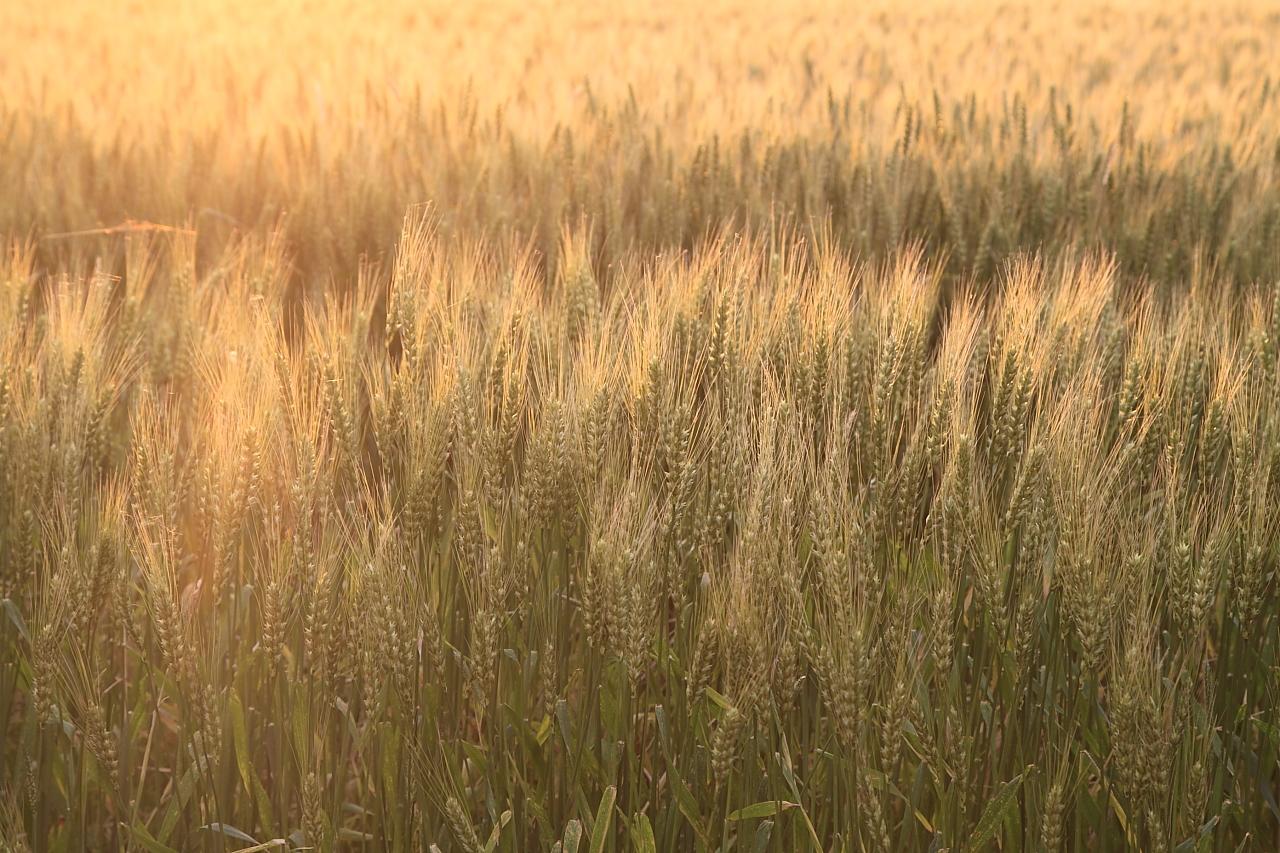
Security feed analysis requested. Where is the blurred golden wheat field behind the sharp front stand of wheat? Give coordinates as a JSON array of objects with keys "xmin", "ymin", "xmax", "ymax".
[{"xmin": 0, "ymin": 0, "xmax": 1280, "ymax": 280}]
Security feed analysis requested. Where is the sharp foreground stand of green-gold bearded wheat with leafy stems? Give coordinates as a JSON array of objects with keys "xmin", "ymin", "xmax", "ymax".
[{"xmin": 0, "ymin": 215, "xmax": 1280, "ymax": 852}]
